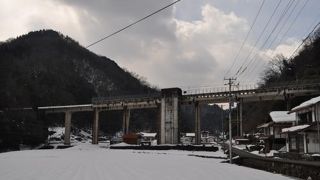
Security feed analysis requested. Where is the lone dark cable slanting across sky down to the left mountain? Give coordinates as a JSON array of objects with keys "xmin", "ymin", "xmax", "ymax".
[{"xmin": 86, "ymin": 0, "xmax": 181, "ymax": 48}]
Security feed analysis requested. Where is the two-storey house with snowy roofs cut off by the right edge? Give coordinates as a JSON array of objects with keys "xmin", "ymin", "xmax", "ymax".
[{"xmin": 282, "ymin": 96, "xmax": 320, "ymax": 153}]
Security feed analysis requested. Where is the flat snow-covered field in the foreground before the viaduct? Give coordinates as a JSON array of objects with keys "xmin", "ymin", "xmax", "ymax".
[{"xmin": 0, "ymin": 144, "xmax": 291, "ymax": 180}]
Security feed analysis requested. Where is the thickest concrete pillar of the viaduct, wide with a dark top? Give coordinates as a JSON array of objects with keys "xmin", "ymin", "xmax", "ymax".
[{"xmin": 160, "ymin": 88, "xmax": 182, "ymax": 144}]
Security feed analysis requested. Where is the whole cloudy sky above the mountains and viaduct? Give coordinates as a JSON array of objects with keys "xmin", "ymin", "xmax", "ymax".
[{"xmin": 0, "ymin": 0, "xmax": 320, "ymax": 88}]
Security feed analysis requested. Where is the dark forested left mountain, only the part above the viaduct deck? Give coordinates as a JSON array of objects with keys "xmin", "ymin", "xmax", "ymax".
[{"xmin": 0, "ymin": 30, "xmax": 155, "ymax": 109}]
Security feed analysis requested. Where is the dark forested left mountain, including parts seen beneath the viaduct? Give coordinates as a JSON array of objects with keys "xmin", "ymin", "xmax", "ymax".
[{"xmin": 0, "ymin": 30, "xmax": 157, "ymax": 151}]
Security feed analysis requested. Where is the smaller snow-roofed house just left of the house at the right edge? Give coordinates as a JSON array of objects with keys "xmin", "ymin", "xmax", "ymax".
[{"xmin": 257, "ymin": 111, "xmax": 296, "ymax": 152}]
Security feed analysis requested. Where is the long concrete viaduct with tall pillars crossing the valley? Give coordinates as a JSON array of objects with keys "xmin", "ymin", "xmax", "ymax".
[{"xmin": 38, "ymin": 83, "xmax": 320, "ymax": 145}]
